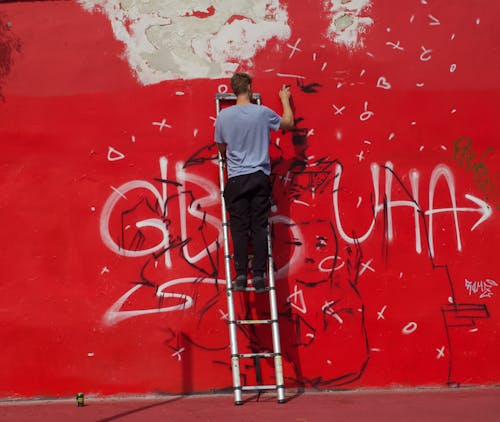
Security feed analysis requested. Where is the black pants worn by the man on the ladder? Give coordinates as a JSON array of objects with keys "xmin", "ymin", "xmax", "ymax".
[{"xmin": 224, "ymin": 171, "xmax": 271, "ymax": 277}]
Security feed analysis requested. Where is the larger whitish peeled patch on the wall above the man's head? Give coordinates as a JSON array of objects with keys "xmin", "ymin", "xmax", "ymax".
[{"xmin": 78, "ymin": 0, "xmax": 290, "ymax": 85}]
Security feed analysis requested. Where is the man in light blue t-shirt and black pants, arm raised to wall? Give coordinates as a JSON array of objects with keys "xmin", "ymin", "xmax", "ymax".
[{"xmin": 215, "ymin": 73, "xmax": 294, "ymax": 293}]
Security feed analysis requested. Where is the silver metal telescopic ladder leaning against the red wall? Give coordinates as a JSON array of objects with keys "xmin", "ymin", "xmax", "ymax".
[{"xmin": 215, "ymin": 93, "xmax": 286, "ymax": 405}]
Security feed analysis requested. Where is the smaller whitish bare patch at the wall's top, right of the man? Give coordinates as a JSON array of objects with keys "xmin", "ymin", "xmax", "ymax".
[{"xmin": 325, "ymin": 0, "xmax": 373, "ymax": 48}]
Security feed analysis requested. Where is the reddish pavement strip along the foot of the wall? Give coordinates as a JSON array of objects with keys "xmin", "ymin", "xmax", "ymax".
[{"xmin": 0, "ymin": 387, "xmax": 500, "ymax": 422}]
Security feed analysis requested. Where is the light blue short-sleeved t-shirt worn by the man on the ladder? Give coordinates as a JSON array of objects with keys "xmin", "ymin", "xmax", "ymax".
[{"xmin": 215, "ymin": 103, "xmax": 281, "ymax": 177}]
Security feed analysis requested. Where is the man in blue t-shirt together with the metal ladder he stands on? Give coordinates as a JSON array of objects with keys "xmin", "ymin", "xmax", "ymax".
[{"xmin": 215, "ymin": 73, "xmax": 294, "ymax": 404}]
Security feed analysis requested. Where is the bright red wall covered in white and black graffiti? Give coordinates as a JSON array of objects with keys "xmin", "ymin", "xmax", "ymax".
[{"xmin": 0, "ymin": 0, "xmax": 500, "ymax": 397}]
